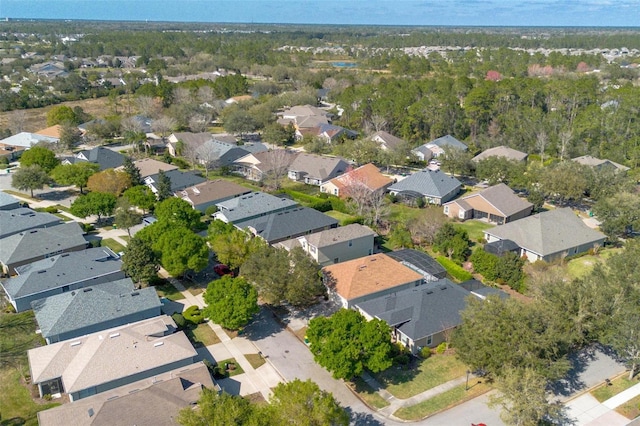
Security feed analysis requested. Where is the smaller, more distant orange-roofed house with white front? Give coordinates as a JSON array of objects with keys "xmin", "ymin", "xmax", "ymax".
[{"xmin": 320, "ymin": 163, "xmax": 393, "ymax": 198}]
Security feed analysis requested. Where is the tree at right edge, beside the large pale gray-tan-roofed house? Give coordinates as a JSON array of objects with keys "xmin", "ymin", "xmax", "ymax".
[{"xmin": 593, "ymin": 192, "xmax": 640, "ymax": 241}]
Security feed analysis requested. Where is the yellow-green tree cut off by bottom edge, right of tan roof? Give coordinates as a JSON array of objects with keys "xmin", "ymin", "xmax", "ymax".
[{"xmin": 266, "ymin": 379, "xmax": 349, "ymax": 426}]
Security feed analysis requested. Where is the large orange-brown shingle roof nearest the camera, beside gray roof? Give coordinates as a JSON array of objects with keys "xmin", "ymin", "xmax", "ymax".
[{"xmin": 322, "ymin": 253, "xmax": 422, "ymax": 300}]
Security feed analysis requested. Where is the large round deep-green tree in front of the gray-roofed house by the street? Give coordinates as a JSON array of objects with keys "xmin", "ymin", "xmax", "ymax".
[{"xmin": 307, "ymin": 309, "xmax": 392, "ymax": 379}]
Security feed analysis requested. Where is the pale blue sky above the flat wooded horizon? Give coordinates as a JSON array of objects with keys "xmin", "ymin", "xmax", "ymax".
[{"xmin": 0, "ymin": 0, "xmax": 640, "ymax": 27}]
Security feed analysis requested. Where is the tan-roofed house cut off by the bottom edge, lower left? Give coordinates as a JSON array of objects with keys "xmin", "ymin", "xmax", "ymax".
[{"xmin": 38, "ymin": 362, "xmax": 217, "ymax": 426}]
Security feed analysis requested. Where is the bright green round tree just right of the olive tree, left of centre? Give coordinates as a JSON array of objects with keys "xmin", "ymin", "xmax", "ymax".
[{"xmin": 153, "ymin": 226, "xmax": 209, "ymax": 277}]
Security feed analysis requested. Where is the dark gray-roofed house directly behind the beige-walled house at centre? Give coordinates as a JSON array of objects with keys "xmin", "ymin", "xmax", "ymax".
[{"xmin": 238, "ymin": 207, "xmax": 338, "ymax": 244}]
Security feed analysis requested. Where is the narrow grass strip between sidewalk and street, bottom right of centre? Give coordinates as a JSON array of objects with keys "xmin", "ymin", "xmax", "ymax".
[{"xmin": 393, "ymin": 382, "xmax": 491, "ymax": 421}]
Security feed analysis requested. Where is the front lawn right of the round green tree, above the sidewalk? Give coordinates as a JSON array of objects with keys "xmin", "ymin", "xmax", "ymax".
[{"xmin": 376, "ymin": 355, "xmax": 467, "ymax": 399}]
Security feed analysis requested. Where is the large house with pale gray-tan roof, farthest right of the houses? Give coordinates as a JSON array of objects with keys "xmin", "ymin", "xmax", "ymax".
[{"xmin": 484, "ymin": 208, "xmax": 605, "ymax": 262}]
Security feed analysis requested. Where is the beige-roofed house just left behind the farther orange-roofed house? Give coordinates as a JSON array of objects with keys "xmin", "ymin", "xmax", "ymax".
[{"xmin": 288, "ymin": 153, "xmax": 349, "ymax": 186}]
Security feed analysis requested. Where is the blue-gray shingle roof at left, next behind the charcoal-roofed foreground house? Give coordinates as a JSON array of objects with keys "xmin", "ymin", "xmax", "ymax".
[{"xmin": 3, "ymin": 247, "xmax": 122, "ymax": 299}]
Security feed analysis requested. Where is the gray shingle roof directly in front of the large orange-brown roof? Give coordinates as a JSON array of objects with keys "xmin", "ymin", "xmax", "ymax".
[{"xmin": 358, "ymin": 278, "xmax": 471, "ymax": 340}]
